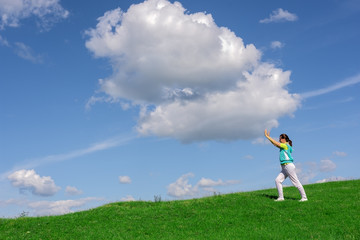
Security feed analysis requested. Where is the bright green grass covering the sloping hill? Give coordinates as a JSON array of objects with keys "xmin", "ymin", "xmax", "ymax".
[{"xmin": 0, "ymin": 180, "xmax": 360, "ymax": 240}]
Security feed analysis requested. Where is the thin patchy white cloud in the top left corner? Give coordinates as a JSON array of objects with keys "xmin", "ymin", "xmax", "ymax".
[{"xmin": 0, "ymin": 0, "xmax": 69, "ymax": 29}]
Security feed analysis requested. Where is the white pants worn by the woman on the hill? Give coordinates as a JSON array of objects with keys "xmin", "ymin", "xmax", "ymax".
[{"xmin": 275, "ymin": 163, "xmax": 307, "ymax": 199}]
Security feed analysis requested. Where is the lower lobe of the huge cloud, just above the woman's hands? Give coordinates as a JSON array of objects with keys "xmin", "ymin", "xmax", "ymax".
[{"xmin": 138, "ymin": 64, "xmax": 298, "ymax": 142}]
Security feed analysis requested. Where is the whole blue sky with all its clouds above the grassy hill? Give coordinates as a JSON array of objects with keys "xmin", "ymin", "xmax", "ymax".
[{"xmin": 0, "ymin": 0, "xmax": 360, "ymax": 217}]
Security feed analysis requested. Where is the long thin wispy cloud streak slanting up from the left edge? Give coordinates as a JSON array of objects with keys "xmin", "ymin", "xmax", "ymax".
[{"xmin": 0, "ymin": 135, "xmax": 137, "ymax": 180}]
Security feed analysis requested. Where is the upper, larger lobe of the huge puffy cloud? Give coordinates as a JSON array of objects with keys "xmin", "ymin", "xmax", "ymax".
[{"xmin": 86, "ymin": 0, "xmax": 260, "ymax": 102}]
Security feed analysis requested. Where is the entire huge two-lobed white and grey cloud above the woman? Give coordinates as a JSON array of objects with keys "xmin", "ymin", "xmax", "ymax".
[{"xmin": 86, "ymin": 0, "xmax": 299, "ymax": 142}]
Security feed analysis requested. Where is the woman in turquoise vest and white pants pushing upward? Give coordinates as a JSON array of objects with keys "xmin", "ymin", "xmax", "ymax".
[{"xmin": 265, "ymin": 129, "xmax": 308, "ymax": 202}]
